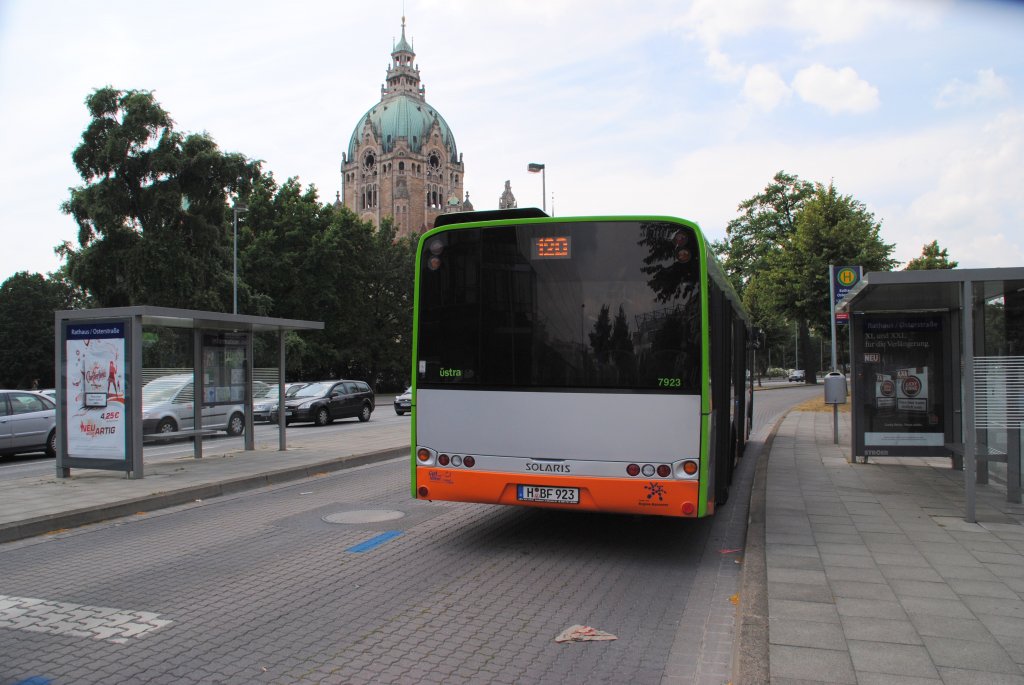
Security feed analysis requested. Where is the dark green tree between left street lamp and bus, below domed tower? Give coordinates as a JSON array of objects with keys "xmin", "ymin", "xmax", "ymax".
[{"xmin": 240, "ymin": 175, "xmax": 416, "ymax": 388}]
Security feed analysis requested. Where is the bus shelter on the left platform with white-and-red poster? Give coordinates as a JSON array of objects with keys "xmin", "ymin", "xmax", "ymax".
[{"xmin": 54, "ymin": 306, "xmax": 324, "ymax": 478}]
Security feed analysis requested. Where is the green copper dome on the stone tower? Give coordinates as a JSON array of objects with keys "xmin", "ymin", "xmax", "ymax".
[{"xmin": 348, "ymin": 94, "xmax": 459, "ymax": 163}]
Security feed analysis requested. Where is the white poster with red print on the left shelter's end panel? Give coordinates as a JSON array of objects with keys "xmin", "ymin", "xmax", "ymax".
[{"xmin": 65, "ymin": 322, "xmax": 127, "ymax": 459}]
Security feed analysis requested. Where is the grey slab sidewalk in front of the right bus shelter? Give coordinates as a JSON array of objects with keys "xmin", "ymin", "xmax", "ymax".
[{"xmin": 757, "ymin": 412, "xmax": 1024, "ymax": 684}]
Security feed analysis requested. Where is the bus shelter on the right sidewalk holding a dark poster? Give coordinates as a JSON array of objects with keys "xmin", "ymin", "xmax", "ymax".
[{"xmin": 837, "ymin": 267, "xmax": 1024, "ymax": 522}]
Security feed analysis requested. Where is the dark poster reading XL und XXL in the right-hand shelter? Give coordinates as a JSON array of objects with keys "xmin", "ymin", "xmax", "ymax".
[{"xmin": 857, "ymin": 314, "xmax": 946, "ymax": 457}]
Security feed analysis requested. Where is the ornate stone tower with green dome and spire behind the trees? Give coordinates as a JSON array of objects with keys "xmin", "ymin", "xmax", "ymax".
[{"xmin": 341, "ymin": 16, "xmax": 468, "ymax": 236}]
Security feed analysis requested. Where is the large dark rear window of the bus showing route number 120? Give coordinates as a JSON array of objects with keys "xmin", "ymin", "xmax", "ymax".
[{"xmin": 417, "ymin": 221, "xmax": 700, "ymax": 393}]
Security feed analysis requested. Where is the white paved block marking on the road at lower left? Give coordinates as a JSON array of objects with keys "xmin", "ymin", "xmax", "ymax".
[{"xmin": 0, "ymin": 595, "xmax": 173, "ymax": 644}]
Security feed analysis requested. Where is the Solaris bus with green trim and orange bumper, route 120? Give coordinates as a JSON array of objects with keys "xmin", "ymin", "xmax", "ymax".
[{"xmin": 412, "ymin": 210, "xmax": 753, "ymax": 517}]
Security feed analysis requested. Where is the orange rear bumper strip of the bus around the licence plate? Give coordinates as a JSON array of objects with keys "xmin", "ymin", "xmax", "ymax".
[{"xmin": 416, "ymin": 467, "xmax": 713, "ymax": 518}]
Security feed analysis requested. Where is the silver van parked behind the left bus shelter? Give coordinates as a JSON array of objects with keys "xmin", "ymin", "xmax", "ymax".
[{"xmin": 142, "ymin": 374, "xmax": 246, "ymax": 435}]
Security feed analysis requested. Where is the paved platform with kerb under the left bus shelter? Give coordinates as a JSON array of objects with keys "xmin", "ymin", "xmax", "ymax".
[{"xmin": 0, "ymin": 424, "xmax": 409, "ymax": 543}]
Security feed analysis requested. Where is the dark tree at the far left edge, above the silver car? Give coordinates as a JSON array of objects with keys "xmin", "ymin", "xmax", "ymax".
[{"xmin": 0, "ymin": 271, "xmax": 80, "ymax": 388}]
